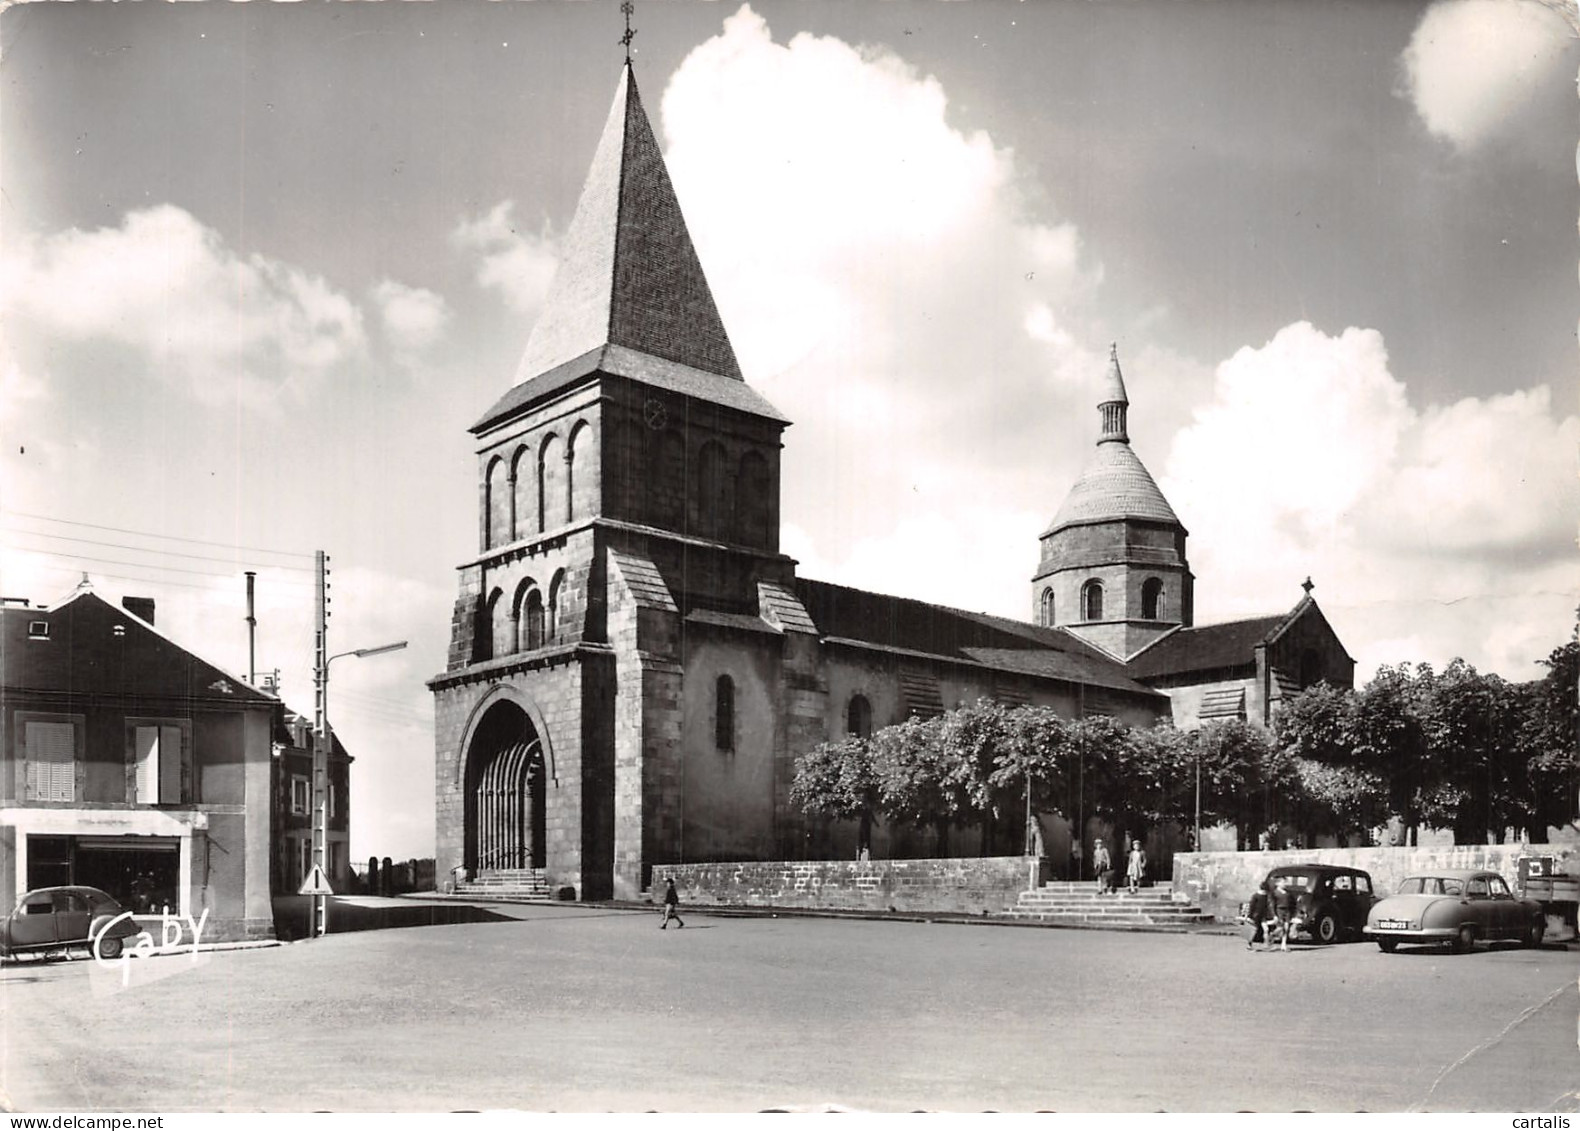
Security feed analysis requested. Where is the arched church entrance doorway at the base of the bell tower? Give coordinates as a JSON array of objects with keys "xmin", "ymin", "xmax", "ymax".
[{"xmin": 466, "ymin": 703, "xmax": 545, "ymax": 875}]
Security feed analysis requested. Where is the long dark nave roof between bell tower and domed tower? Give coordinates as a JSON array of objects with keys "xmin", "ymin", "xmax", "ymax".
[{"xmin": 795, "ymin": 578, "xmax": 1157, "ymax": 695}]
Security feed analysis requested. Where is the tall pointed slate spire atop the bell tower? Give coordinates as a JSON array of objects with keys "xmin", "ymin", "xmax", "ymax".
[{"xmin": 517, "ymin": 65, "xmax": 743, "ymax": 382}]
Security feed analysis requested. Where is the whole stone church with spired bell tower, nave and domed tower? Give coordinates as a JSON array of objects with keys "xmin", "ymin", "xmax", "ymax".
[{"xmin": 428, "ymin": 63, "xmax": 1352, "ymax": 899}]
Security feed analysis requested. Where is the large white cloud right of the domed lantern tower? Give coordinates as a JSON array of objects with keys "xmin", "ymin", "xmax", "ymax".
[{"xmin": 1160, "ymin": 322, "xmax": 1580, "ymax": 678}]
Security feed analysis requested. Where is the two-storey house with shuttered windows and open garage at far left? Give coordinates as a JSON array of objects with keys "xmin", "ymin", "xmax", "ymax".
[{"xmin": 0, "ymin": 581, "xmax": 280, "ymax": 940}]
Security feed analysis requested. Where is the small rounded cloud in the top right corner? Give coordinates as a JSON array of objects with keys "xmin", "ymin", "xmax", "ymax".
[{"xmin": 1400, "ymin": 0, "xmax": 1574, "ymax": 148}]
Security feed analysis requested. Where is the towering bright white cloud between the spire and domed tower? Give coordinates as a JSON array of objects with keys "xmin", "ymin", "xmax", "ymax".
[{"xmin": 666, "ymin": 6, "xmax": 1106, "ymax": 611}]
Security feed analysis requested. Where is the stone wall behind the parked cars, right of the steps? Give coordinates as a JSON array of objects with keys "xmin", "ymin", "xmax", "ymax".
[{"xmin": 1174, "ymin": 844, "xmax": 1580, "ymax": 922}]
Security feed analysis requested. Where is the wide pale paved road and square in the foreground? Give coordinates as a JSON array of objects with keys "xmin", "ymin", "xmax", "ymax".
[{"xmin": 0, "ymin": 907, "xmax": 1580, "ymax": 1112}]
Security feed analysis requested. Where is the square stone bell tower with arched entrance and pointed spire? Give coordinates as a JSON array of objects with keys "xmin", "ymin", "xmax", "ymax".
[{"xmin": 428, "ymin": 60, "xmax": 793, "ymax": 899}]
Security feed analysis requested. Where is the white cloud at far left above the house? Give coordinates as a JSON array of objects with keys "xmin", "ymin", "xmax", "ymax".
[{"xmin": 0, "ymin": 204, "xmax": 367, "ymax": 404}]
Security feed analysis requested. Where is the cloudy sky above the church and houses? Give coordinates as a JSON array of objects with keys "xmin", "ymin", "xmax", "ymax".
[{"xmin": 0, "ymin": 0, "xmax": 1580, "ymax": 859}]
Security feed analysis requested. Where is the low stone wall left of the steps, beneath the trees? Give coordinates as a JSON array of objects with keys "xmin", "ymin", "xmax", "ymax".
[{"xmin": 649, "ymin": 856, "xmax": 1048, "ymax": 915}]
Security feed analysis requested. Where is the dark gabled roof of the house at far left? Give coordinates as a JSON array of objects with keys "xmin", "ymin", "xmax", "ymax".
[{"xmin": 0, "ymin": 589, "xmax": 278, "ymax": 706}]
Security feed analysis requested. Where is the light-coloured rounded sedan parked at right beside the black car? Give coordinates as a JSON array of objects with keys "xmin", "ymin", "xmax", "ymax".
[{"xmin": 1367, "ymin": 870, "xmax": 1547, "ymax": 954}]
